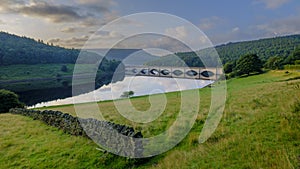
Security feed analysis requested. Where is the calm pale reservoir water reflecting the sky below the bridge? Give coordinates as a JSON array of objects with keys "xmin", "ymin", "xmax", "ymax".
[{"xmin": 30, "ymin": 76, "xmax": 213, "ymax": 108}]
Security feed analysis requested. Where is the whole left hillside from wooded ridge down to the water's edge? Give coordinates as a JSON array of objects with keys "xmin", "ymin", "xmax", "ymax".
[{"xmin": 0, "ymin": 32, "xmax": 124, "ymax": 105}]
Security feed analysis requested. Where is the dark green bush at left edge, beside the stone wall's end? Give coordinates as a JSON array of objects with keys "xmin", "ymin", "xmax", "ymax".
[{"xmin": 0, "ymin": 89, "xmax": 24, "ymax": 113}]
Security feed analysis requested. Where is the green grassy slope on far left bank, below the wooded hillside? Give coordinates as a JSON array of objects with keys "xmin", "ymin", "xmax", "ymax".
[{"xmin": 0, "ymin": 64, "xmax": 96, "ymax": 92}]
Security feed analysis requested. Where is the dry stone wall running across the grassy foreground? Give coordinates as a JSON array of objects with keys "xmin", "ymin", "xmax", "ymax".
[{"xmin": 10, "ymin": 108, "xmax": 143, "ymax": 157}]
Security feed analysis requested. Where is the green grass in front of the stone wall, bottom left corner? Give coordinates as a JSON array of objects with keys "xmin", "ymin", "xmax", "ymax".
[{"xmin": 0, "ymin": 114, "xmax": 138, "ymax": 168}]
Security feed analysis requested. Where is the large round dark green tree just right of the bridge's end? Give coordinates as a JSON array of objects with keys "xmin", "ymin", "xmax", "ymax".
[{"xmin": 236, "ymin": 54, "xmax": 262, "ymax": 76}]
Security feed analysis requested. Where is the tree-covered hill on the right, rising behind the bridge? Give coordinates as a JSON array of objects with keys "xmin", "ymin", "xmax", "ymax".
[{"xmin": 147, "ymin": 35, "xmax": 300, "ymax": 67}]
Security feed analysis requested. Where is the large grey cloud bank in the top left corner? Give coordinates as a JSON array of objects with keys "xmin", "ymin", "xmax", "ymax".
[{"xmin": 0, "ymin": 0, "xmax": 117, "ymax": 27}]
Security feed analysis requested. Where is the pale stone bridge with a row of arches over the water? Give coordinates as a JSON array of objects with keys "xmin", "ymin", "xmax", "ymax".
[{"xmin": 125, "ymin": 66, "xmax": 223, "ymax": 80}]
